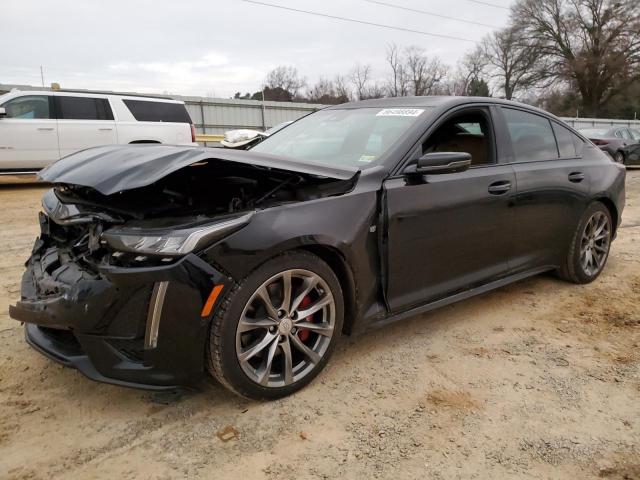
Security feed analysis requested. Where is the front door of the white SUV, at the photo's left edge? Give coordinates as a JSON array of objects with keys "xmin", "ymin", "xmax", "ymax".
[{"xmin": 0, "ymin": 95, "xmax": 60, "ymax": 170}]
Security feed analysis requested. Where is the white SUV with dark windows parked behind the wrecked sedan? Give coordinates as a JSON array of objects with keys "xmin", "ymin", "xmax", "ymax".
[{"xmin": 0, "ymin": 91, "xmax": 196, "ymax": 174}]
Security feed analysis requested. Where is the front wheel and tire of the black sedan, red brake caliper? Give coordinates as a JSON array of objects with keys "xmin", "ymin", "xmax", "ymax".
[{"xmin": 206, "ymin": 251, "xmax": 344, "ymax": 400}]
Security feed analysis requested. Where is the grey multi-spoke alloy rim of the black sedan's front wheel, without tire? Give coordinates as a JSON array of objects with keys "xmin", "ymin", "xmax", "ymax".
[{"xmin": 236, "ymin": 269, "xmax": 336, "ymax": 388}]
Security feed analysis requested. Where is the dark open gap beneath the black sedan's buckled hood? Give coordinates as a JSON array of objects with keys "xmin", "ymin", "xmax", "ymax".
[{"xmin": 55, "ymin": 159, "xmax": 353, "ymax": 223}]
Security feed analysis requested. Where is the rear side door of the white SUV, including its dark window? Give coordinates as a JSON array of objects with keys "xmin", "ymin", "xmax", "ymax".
[{"xmin": 54, "ymin": 94, "xmax": 118, "ymax": 157}]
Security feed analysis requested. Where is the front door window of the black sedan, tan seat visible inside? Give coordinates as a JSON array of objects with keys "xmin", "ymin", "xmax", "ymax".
[{"xmin": 422, "ymin": 110, "xmax": 495, "ymax": 166}]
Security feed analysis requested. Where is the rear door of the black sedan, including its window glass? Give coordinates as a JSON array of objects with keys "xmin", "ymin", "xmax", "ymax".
[{"xmin": 500, "ymin": 107, "xmax": 597, "ymax": 272}]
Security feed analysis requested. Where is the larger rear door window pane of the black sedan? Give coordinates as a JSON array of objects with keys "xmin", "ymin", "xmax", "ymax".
[{"xmin": 502, "ymin": 108, "xmax": 558, "ymax": 162}]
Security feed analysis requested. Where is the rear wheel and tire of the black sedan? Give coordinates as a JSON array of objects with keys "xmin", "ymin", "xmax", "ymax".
[{"xmin": 558, "ymin": 202, "xmax": 613, "ymax": 284}]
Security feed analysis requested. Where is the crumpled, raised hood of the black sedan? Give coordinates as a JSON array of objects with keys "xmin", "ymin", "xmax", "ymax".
[{"xmin": 38, "ymin": 144, "xmax": 358, "ymax": 195}]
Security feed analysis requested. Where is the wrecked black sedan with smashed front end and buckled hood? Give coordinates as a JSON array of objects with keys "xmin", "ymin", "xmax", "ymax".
[{"xmin": 10, "ymin": 97, "xmax": 625, "ymax": 398}]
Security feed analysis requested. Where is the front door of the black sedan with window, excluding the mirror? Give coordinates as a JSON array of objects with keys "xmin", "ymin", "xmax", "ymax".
[{"xmin": 384, "ymin": 108, "xmax": 515, "ymax": 312}]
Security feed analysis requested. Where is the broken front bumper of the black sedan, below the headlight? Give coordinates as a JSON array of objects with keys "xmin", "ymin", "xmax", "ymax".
[{"xmin": 9, "ymin": 239, "xmax": 230, "ymax": 390}]
